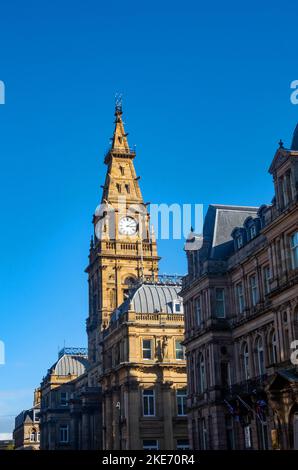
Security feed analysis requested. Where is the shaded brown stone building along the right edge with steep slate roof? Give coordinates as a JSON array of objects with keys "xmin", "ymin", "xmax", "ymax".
[{"xmin": 181, "ymin": 129, "xmax": 298, "ymax": 449}]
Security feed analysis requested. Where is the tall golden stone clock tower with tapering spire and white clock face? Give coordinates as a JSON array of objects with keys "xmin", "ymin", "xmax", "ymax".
[{"xmin": 86, "ymin": 103, "xmax": 160, "ymax": 365}]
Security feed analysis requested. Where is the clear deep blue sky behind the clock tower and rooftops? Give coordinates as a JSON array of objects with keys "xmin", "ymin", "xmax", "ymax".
[{"xmin": 0, "ymin": 0, "xmax": 298, "ymax": 433}]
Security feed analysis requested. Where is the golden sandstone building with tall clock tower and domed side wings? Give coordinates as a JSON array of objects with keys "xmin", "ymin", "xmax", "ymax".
[{"xmin": 35, "ymin": 105, "xmax": 189, "ymax": 450}]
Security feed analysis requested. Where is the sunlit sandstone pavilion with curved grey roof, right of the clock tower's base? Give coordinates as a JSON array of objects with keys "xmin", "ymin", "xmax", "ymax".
[{"xmin": 101, "ymin": 283, "xmax": 189, "ymax": 450}]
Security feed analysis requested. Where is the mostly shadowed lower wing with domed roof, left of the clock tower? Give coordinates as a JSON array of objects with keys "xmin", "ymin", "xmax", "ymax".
[{"xmin": 40, "ymin": 348, "xmax": 101, "ymax": 450}]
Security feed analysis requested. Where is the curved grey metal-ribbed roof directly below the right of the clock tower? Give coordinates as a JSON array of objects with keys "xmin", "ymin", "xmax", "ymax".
[{"xmin": 111, "ymin": 283, "xmax": 183, "ymax": 322}]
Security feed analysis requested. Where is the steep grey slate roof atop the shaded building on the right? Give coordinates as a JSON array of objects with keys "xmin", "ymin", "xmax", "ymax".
[{"xmin": 203, "ymin": 204, "xmax": 259, "ymax": 259}]
